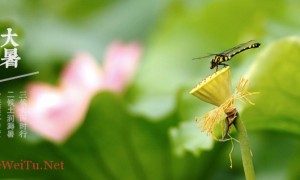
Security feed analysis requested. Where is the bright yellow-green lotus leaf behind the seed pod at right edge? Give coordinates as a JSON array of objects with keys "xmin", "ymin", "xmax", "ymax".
[{"xmin": 243, "ymin": 37, "xmax": 300, "ymax": 135}]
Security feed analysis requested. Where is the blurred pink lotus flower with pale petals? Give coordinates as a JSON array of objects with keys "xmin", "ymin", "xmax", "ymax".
[{"xmin": 16, "ymin": 42, "xmax": 141, "ymax": 143}]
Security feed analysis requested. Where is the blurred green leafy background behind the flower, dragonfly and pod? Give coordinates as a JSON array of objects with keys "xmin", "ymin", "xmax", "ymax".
[{"xmin": 0, "ymin": 0, "xmax": 300, "ymax": 180}]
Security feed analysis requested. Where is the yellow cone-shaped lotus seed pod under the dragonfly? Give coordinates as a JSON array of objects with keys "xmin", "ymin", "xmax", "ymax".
[{"xmin": 190, "ymin": 66, "xmax": 232, "ymax": 106}]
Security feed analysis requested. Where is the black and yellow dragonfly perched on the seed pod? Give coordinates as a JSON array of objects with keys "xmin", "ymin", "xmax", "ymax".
[{"xmin": 193, "ymin": 40, "xmax": 260, "ymax": 71}]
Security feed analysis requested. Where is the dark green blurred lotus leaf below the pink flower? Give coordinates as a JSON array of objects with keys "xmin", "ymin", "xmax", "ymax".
[{"xmin": 0, "ymin": 93, "xmax": 221, "ymax": 179}]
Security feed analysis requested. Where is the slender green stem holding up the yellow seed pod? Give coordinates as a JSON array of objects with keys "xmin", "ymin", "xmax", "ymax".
[{"xmin": 234, "ymin": 115, "xmax": 255, "ymax": 180}]
